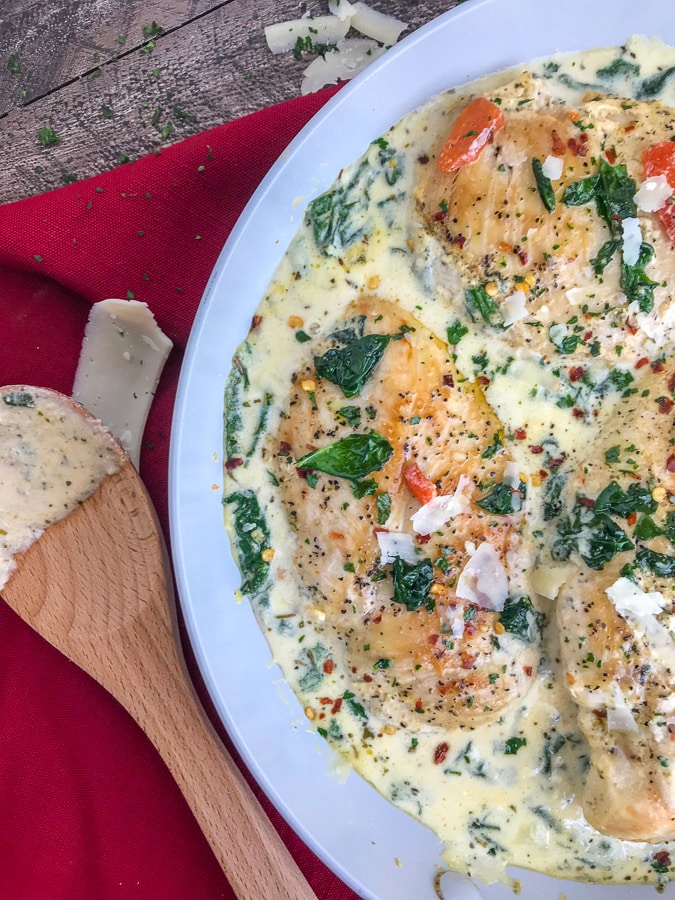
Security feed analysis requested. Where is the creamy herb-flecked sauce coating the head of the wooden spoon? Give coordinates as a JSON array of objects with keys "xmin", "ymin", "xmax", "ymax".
[{"xmin": 0, "ymin": 387, "xmax": 119, "ymax": 588}]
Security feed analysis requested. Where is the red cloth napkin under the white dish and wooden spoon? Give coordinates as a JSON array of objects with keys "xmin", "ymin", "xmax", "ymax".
[{"xmin": 0, "ymin": 91, "xmax": 364, "ymax": 900}]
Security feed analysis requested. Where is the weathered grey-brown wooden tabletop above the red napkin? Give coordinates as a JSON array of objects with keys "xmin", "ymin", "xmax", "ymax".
[{"xmin": 0, "ymin": 0, "xmax": 461, "ymax": 203}]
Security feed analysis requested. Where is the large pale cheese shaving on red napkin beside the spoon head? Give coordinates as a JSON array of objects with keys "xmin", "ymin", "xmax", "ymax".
[{"xmin": 73, "ymin": 299, "xmax": 173, "ymax": 467}]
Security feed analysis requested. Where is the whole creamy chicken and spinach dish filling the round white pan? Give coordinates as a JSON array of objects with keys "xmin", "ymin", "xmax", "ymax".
[{"xmin": 224, "ymin": 33, "xmax": 675, "ymax": 885}]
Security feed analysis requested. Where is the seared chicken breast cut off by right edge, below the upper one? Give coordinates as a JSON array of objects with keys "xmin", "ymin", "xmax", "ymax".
[{"xmin": 557, "ymin": 364, "xmax": 675, "ymax": 842}]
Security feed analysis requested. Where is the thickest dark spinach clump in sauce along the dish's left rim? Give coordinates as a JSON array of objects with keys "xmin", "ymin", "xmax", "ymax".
[{"xmin": 223, "ymin": 490, "xmax": 270, "ymax": 597}]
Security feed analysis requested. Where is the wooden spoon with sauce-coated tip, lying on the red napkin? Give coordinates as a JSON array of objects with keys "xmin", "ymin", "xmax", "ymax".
[{"xmin": 0, "ymin": 387, "xmax": 315, "ymax": 900}]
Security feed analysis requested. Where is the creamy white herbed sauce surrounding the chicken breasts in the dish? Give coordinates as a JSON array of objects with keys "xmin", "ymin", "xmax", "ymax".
[{"xmin": 226, "ymin": 41, "xmax": 675, "ymax": 883}]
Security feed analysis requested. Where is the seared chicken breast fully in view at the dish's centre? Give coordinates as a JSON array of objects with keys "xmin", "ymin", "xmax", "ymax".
[{"xmin": 267, "ymin": 296, "xmax": 539, "ymax": 729}]
